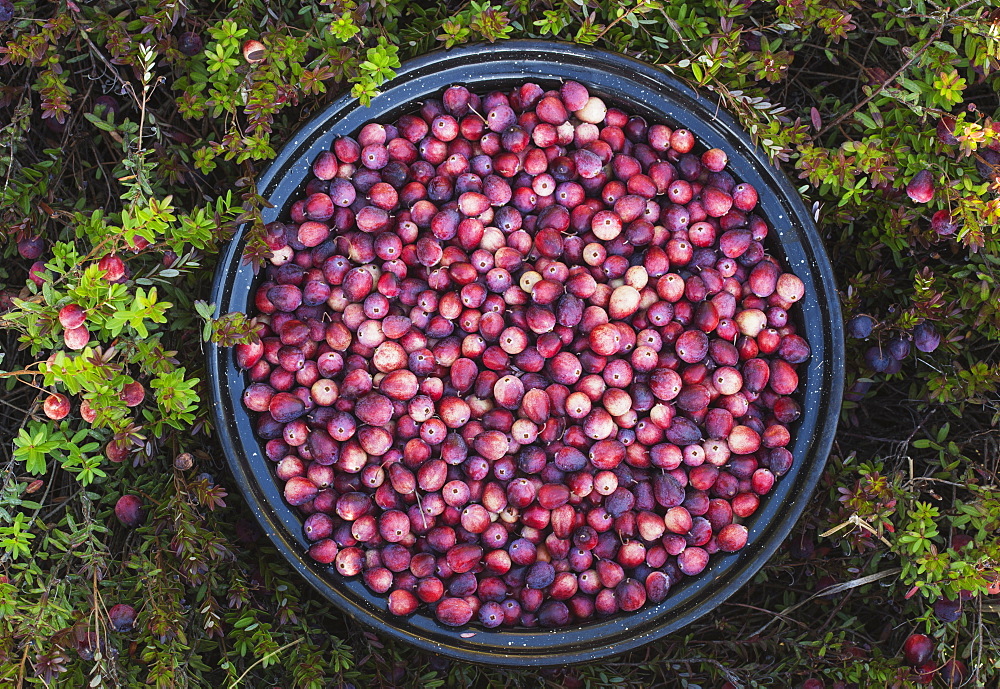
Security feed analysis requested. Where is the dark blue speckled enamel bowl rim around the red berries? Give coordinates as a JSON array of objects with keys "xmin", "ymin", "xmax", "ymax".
[{"xmin": 207, "ymin": 41, "xmax": 844, "ymax": 667}]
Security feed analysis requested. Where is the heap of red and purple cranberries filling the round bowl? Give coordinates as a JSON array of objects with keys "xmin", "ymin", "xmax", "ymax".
[{"xmin": 235, "ymin": 82, "xmax": 810, "ymax": 627}]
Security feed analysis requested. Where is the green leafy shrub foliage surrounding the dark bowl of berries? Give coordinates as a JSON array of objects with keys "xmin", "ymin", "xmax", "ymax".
[{"xmin": 0, "ymin": 0, "xmax": 1000, "ymax": 689}]
